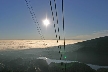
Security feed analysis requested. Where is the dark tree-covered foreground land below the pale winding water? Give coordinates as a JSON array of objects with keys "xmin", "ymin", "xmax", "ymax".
[{"xmin": 0, "ymin": 58, "xmax": 108, "ymax": 72}]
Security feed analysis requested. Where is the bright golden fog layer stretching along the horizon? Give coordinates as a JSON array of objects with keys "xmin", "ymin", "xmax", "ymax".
[{"xmin": 0, "ymin": 40, "xmax": 83, "ymax": 50}]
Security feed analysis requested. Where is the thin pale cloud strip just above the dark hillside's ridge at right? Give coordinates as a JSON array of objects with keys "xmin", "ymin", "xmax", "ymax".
[{"xmin": 72, "ymin": 30, "xmax": 108, "ymax": 40}]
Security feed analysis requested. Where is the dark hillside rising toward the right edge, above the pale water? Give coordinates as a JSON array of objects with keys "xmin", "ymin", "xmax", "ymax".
[{"xmin": 66, "ymin": 36, "xmax": 108, "ymax": 66}]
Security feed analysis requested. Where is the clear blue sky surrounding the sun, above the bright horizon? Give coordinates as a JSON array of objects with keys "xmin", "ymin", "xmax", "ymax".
[{"xmin": 0, "ymin": 0, "xmax": 108, "ymax": 40}]
